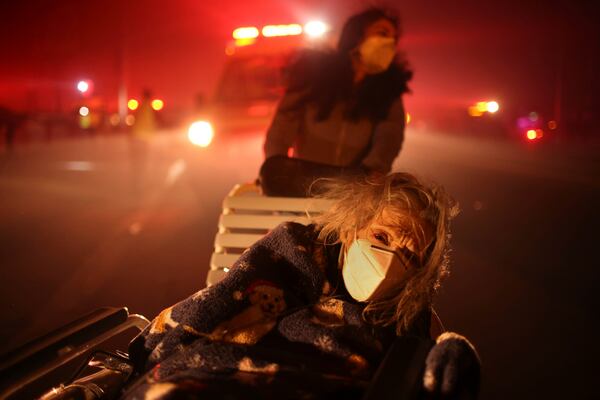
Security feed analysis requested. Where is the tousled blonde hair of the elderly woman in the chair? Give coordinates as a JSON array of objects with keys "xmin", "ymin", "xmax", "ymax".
[{"xmin": 312, "ymin": 173, "xmax": 458, "ymax": 335}]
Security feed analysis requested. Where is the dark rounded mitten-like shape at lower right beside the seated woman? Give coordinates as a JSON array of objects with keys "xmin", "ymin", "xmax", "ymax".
[{"xmin": 423, "ymin": 332, "xmax": 481, "ymax": 399}]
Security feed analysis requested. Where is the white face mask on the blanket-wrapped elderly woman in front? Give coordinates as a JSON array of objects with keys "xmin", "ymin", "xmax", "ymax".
[{"xmin": 342, "ymin": 239, "xmax": 408, "ymax": 301}]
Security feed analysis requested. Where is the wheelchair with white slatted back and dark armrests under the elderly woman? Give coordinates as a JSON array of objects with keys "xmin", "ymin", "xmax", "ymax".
[{"xmin": 0, "ymin": 184, "xmax": 433, "ymax": 400}]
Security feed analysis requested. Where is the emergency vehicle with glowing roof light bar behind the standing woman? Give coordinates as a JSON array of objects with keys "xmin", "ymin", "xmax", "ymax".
[{"xmin": 188, "ymin": 21, "xmax": 330, "ymax": 147}]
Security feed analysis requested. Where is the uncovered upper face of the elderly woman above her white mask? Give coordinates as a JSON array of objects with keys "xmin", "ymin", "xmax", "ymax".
[{"xmin": 356, "ymin": 210, "xmax": 433, "ymax": 266}]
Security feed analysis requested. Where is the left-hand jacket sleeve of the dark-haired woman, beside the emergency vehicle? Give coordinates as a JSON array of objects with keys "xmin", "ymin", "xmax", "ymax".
[{"xmin": 264, "ymin": 90, "xmax": 304, "ymax": 158}]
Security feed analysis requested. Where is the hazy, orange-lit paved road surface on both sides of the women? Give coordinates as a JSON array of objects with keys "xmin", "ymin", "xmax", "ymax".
[{"xmin": 0, "ymin": 127, "xmax": 600, "ymax": 399}]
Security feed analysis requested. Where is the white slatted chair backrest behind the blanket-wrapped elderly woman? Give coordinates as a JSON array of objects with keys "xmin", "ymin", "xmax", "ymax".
[{"xmin": 206, "ymin": 184, "xmax": 331, "ymax": 286}]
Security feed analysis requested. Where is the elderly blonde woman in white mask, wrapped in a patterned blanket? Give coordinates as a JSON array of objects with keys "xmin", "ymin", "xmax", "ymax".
[{"xmin": 120, "ymin": 173, "xmax": 479, "ymax": 398}]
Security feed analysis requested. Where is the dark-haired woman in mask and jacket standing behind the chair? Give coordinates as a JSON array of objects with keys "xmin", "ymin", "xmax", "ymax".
[{"xmin": 261, "ymin": 8, "xmax": 412, "ymax": 195}]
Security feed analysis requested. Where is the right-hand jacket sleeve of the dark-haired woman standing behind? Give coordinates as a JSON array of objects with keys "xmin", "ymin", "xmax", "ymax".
[{"xmin": 362, "ymin": 96, "xmax": 406, "ymax": 174}]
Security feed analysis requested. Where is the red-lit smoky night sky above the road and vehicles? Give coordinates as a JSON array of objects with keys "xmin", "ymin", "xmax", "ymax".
[{"xmin": 0, "ymin": 0, "xmax": 598, "ymax": 126}]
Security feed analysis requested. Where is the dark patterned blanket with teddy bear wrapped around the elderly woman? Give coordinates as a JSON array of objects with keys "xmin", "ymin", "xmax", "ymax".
[{"xmin": 129, "ymin": 223, "xmax": 426, "ymax": 398}]
